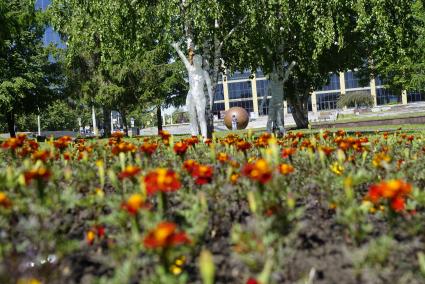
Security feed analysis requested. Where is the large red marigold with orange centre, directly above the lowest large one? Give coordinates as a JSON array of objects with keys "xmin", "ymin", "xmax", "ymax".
[{"xmin": 145, "ymin": 168, "xmax": 181, "ymax": 195}]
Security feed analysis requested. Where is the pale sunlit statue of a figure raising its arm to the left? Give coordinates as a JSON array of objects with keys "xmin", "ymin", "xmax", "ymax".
[{"xmin": 172, "ymin": 43, "xmax": 212, "ymax": 139}]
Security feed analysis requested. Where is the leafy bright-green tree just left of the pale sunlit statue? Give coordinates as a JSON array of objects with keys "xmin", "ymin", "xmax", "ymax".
[{"xmin": 51, "ymin": 0, "xmax": 184, "ymax": 135}]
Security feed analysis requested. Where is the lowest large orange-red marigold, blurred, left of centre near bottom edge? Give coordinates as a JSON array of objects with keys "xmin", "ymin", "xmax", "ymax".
[{"xmin": 143, "ymin": 221, "xmax": 191, "ymax": 249}]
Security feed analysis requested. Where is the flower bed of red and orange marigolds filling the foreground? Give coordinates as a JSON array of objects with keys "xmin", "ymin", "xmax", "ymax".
[{"xmin": 0, "ymin": 130, "xmax": 425, "ymax": 284}]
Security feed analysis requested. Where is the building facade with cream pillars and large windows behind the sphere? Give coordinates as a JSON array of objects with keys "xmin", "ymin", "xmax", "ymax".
[{"xmin": 213, "ymin": 71, "xmax": 425, "ymax": 118}]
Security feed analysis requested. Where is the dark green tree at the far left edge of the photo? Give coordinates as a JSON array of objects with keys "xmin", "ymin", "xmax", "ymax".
[{"xmin": 0, "ymin": 0, "xmax": 61, "ymax": 136}]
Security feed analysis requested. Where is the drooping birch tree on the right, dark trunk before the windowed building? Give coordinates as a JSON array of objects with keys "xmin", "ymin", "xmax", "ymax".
[{"xmin": 226, "ymin": 0, "xmax": 418, "ymax": 128}]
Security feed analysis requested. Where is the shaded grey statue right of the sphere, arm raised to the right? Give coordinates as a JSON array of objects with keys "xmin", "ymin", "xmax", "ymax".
[{"xmin": 262, "ymin": 62, "xmax": 295, "ymax": 134}]
